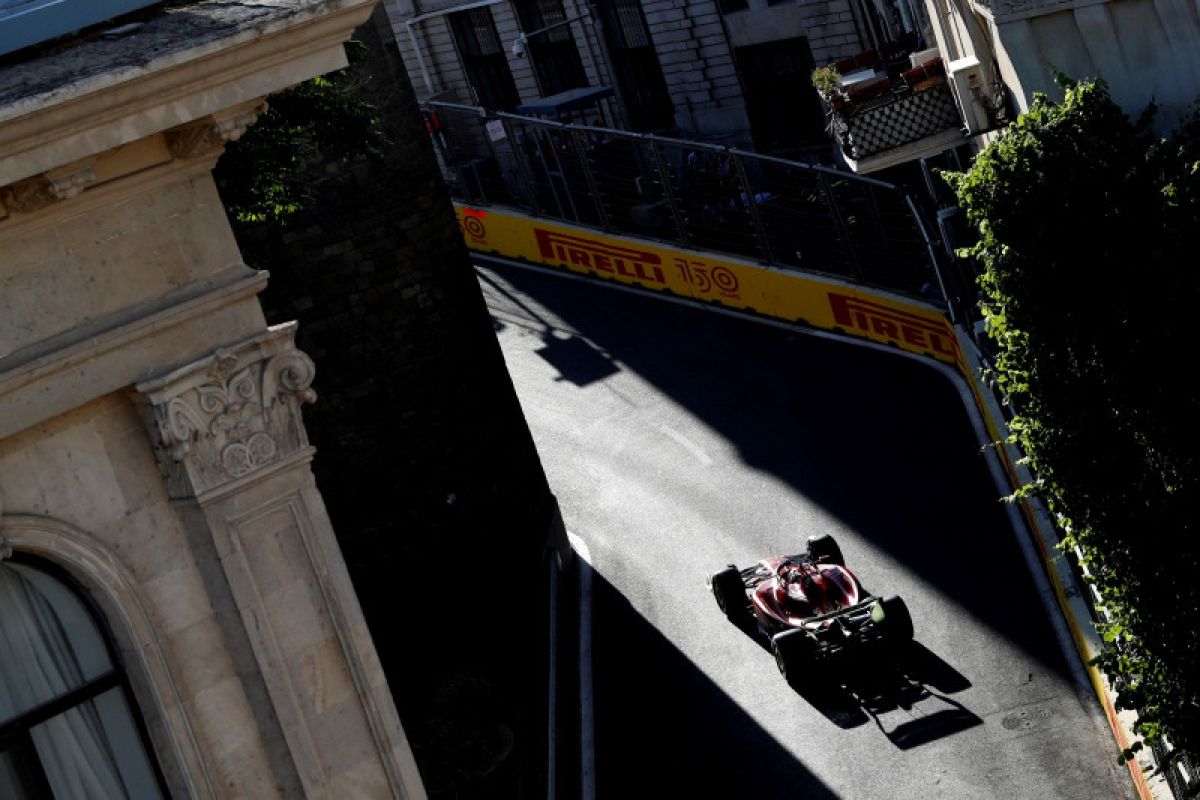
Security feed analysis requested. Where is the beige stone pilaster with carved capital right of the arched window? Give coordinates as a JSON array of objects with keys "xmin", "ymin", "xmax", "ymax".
[{"xmin": 136, "ymin": 323, "xmax": 424, "ymax": 798}]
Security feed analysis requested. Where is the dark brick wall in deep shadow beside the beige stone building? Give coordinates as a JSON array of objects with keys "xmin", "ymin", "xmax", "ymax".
[{"xmin": 224, "ymin": 10, "xmax": 557, "ymax": 798}]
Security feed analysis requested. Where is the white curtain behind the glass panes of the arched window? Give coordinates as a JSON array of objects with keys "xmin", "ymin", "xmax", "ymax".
[{"xmin": 0, "ymin": 565, "xmax": 131, "ymax": 800}]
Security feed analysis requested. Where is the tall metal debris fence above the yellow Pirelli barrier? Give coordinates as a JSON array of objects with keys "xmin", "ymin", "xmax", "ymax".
[{"xmin": 422, "ymin": 102, "xmax": 944, "ymax": 303}]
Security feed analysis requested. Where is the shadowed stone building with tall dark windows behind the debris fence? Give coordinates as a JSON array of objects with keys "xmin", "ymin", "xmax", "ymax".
[{"xmin": 384, "ymin": 0, "xmax": 924, "ymax": 155}]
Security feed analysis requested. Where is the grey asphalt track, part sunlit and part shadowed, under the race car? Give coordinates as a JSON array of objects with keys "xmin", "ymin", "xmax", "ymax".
[{"xmin": 479, "ymin": 266, "xmax": 1135, "ymax": 800}]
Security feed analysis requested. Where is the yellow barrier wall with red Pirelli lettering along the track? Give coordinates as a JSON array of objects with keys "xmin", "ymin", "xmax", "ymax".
[{"xmin": 455, "ymin": 204, "xmax": 965, "ymax": 369}]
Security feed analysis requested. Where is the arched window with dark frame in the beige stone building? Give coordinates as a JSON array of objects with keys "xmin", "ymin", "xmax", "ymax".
[{"xmin": 0, "ymin": 557, "xmax": 166, "ymax": 800}]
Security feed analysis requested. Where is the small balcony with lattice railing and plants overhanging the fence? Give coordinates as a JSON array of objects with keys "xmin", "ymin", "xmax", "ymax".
[{"xmin": 822, "ymin": 44, "xmax": 968, "ymax": 174}]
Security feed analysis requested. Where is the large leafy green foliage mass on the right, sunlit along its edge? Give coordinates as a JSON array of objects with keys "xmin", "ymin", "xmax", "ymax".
[{"xmin": 949, "ymin": 80, "xmax": 1200, "ymax": 757}]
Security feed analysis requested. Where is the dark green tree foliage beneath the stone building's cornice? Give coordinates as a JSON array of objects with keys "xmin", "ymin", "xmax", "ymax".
[{"xmin": 214, "ymin": 42, "xmax": 388, "ymax": 222}]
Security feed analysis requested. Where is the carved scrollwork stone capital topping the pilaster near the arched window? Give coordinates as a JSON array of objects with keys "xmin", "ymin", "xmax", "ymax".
[{"xmin": 136, "ymin": 323, "xmax": 317, "ymax": 499}]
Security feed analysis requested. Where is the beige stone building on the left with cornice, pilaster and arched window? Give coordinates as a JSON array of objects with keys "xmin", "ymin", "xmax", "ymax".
[{"xmin": 0, "ymin": 0, "xmax": 425, "ymax": 798}]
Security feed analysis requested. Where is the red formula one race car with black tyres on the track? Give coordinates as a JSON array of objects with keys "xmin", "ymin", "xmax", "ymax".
[{"xmin": 710, "ymin": 536, "xmax": 912, "ymax": 686}]
